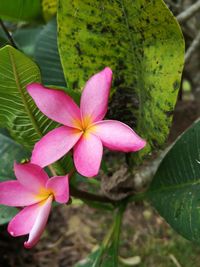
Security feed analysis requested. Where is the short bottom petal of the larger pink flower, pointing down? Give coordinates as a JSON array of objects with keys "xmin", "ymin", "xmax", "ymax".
[{"xmin": 74, "ymin": 133, "xmax": 103, "ymax": 177}]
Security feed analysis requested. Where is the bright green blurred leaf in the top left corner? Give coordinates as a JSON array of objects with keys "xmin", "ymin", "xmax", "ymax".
[{"xmin": 0, "ymin": 0, "xmax": 42, "ymax": 21}]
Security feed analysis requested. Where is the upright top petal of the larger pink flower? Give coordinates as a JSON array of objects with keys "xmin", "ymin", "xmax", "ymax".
[{"xmin": 80, "ymin": 67, "xmax": 112, "ymax": 122}]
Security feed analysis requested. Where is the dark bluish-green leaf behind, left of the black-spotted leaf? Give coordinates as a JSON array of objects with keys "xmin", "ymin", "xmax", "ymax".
[{"xmin": 34, "ymin": 19, "xmax": 66, "ymax": 86}]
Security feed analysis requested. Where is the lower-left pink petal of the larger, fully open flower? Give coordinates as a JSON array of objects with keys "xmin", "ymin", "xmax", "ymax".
[{"xmin": 31, "ymin": 126, "xmax": 82, "ymax": 167}]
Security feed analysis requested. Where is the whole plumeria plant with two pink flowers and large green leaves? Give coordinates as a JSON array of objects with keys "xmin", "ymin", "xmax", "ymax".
[{"xmin": 0, "ymin": 0, "xmax": 200, "ymax": 267}]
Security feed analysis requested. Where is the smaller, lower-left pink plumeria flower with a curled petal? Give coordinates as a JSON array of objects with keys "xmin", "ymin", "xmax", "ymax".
[{"xmin": 0, "ymin": 163, "xmax": 69, "ymax": 248}]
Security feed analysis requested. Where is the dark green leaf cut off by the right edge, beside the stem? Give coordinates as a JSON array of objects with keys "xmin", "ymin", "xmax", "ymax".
[{"xmin": 148, "ymin": 121, "xmax": 200, "ymax": 243}]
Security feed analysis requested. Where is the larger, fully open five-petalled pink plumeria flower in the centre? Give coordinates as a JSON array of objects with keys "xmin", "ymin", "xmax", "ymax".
[{"xmin": 27, "ymin": 67, "xmax": 146, "ymax": 177}]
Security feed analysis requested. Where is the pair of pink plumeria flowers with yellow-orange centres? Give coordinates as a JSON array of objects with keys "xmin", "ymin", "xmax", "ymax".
[{"xmin": 0, "ymin": 67, "xmax": 146, "ymax": 248}]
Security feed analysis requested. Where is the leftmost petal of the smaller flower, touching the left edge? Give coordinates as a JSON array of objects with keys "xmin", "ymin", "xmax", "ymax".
[{"xmin": 0, "ymin": 181, "xmax": 38, "ymax": 207}]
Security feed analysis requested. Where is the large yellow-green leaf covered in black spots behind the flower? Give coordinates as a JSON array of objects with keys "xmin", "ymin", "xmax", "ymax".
[{"xmin": 58, "ymin": 0, "xmax": 184, "ymax": 161}]
